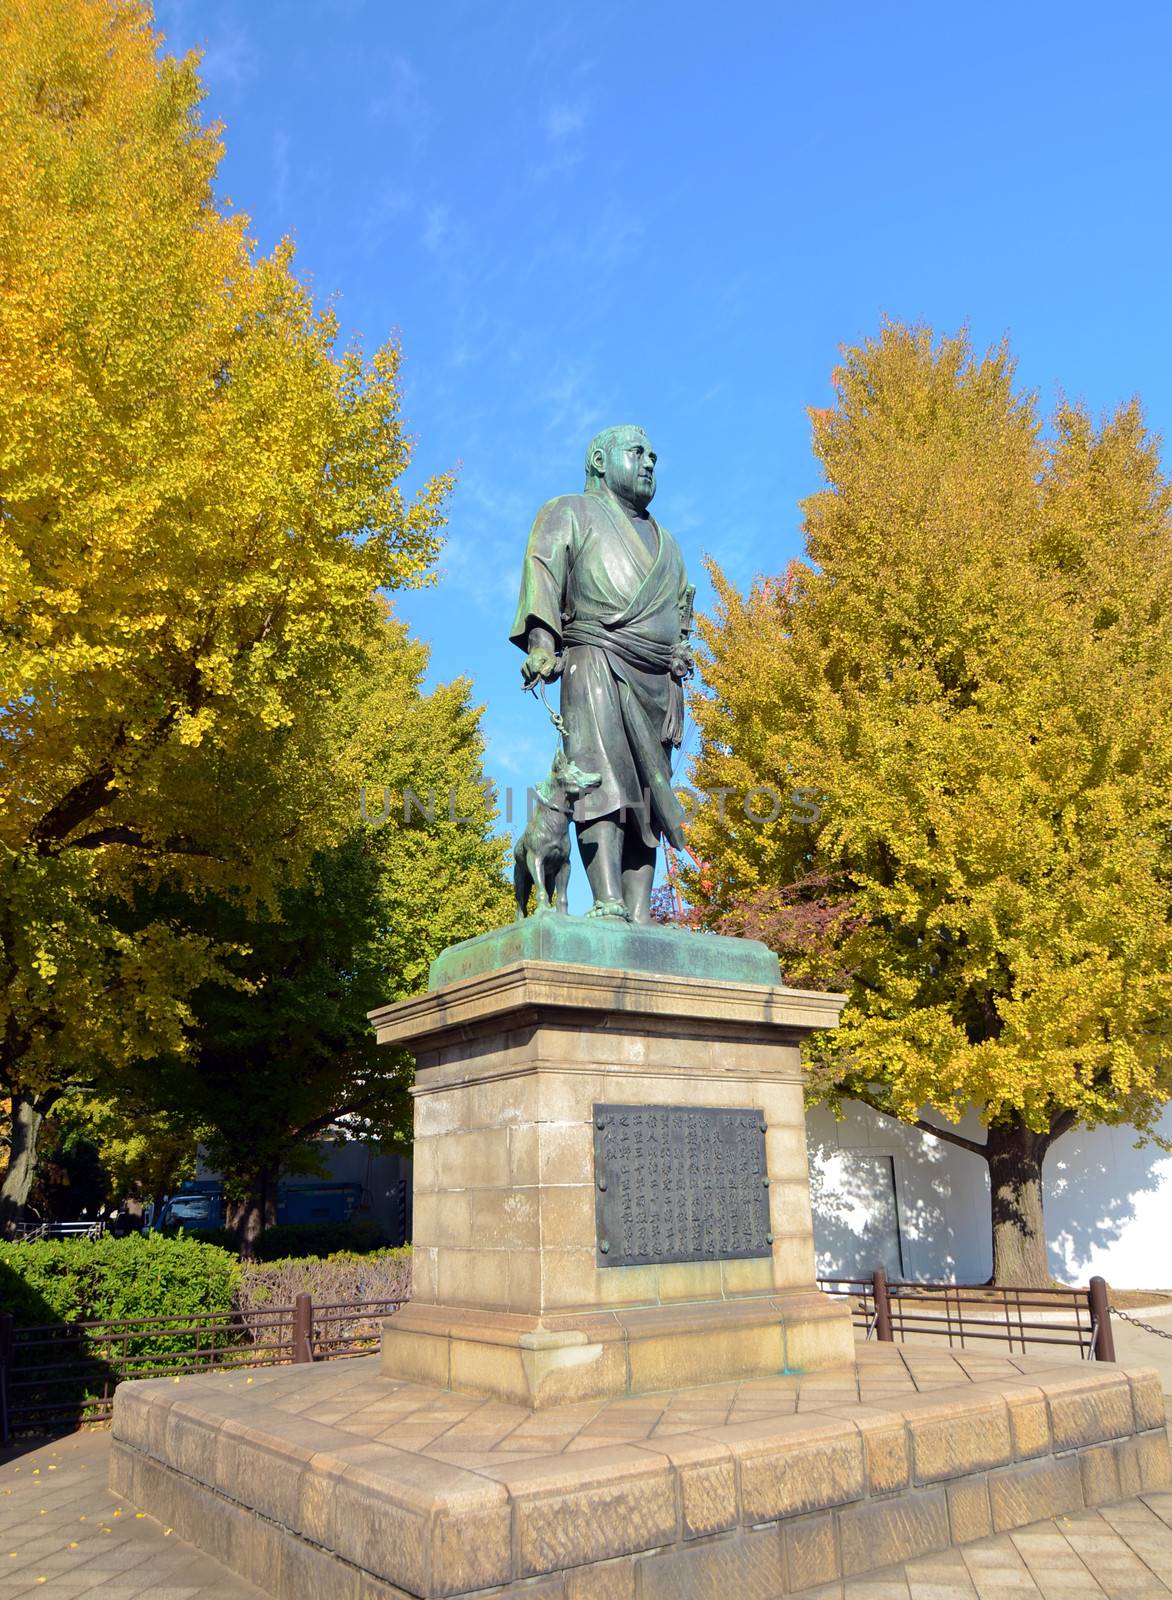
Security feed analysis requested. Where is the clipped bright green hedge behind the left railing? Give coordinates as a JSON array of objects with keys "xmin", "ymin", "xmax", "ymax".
[{"xmin": 0, "ymin": 1234, "xmax": 240, "ymax": 1326}]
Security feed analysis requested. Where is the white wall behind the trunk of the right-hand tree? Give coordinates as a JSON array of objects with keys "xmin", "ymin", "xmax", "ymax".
[{"xmin": 807, "ymin": 1101, "xmax": 1172, "ymax": 1288}]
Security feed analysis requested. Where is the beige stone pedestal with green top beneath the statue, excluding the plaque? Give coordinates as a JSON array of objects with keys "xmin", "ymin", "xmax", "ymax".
[{"xmin": 371, "ymin": 917, "xmax": 852, "ymax": 1406}]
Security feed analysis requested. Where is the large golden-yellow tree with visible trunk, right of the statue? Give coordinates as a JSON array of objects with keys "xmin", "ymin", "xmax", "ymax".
[{"xmin": 692, "ymin": 325, "xmax": 1172, "ymax": 1285}]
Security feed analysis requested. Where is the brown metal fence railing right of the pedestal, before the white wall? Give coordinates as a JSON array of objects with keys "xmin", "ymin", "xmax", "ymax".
[{"xmin": 818, "ymin": 1267, "xmax": 1114, "ymax": 1362}]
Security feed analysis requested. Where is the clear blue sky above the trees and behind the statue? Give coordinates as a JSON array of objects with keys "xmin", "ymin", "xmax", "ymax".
[{"xmin": 157, "ymin": 0, "xmax": 1172, "ymax": 838}]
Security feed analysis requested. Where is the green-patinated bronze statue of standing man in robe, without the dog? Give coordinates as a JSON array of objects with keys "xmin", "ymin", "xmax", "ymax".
[{"xmin": 509, "ymin": 427, "xmax": 695, "ymax": 922}]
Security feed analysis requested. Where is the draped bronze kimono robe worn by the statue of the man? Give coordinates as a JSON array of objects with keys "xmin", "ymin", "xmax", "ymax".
[{"xmin": 509, "ymin": 483, "xmax": 687, "ymax": 850}]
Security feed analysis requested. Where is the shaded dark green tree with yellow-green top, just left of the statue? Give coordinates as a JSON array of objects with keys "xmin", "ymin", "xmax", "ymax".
[{"xmin": 88, "ymin": 619, "xmax": 511, "ymax": 1253}]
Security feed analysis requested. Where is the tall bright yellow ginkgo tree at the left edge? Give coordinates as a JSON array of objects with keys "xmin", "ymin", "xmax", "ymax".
[{"xmin": 0, "ymin": 0, "xmax": 450, "ymax": 1224}]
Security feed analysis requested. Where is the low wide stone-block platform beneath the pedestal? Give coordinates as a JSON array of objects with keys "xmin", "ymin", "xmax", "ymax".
[{"xmin": 110, "ymin": 1346, "xmax": 1170, "ymax": 1600}]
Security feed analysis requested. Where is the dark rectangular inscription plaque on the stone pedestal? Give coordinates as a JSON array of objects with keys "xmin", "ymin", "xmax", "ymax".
[{"xmin": 594, "ymin": 1106, "xmax": 773, "ymax": 1267}]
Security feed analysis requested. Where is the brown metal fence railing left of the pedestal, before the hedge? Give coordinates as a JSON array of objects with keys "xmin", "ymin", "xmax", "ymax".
[{"xmin": 0, "ymin": 1294, "xmax": 402, "ymax": 1443}]
